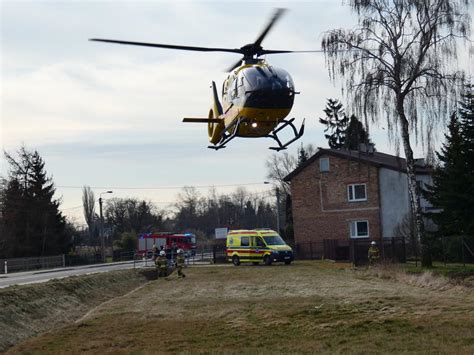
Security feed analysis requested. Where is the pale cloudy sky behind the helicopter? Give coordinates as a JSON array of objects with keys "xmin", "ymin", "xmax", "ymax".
[{"xmin": 0, "ymin": 0, "xmax": 472, "ymax": 224}]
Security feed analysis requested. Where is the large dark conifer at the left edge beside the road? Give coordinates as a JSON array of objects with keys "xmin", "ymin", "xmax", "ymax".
[{"xmin": 1, "ymin": 147, "xmax": 69, "ymax": 258}]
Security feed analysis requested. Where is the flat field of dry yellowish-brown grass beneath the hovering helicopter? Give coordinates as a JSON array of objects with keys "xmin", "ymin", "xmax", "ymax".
[{"xmin": 9, "ymin": 261, "xmax": 474, "ymax": 354}]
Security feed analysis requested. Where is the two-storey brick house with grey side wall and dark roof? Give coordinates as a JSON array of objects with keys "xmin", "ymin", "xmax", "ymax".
[{"xmin": 284, "ymin": 148, "xmax": 431, "ymax": 257}]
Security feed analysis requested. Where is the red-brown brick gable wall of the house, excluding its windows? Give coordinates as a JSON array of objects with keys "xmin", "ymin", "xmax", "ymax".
[{"xmin": 291, "ymin": 155, "xmax": 380, "ymax": 256}]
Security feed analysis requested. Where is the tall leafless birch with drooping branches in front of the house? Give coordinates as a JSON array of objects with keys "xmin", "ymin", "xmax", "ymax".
[{"xmin": 322, "ymin": 0, "xmax": 470, "ymax": 266}]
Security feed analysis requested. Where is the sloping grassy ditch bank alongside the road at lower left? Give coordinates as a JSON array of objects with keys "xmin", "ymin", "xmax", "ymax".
[{"xmin": 0, "ymin": 270, "xmax": 154, "ymax": 352}]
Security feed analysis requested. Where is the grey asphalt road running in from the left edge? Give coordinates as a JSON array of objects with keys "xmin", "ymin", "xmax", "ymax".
[{"xmin": 0, "ymin": 261, "xmax": 146, "ymax": 288}]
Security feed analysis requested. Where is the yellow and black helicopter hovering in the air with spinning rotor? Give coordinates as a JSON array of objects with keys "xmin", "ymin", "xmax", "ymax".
[{"xmin": 90, "ymin": 9, "xmax": 321, "ymax": 151}]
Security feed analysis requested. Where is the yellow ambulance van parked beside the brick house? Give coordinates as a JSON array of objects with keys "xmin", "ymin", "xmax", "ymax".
[{"xmin": 226, "ymin": 229, "xmax": 294, "ymax": 266}]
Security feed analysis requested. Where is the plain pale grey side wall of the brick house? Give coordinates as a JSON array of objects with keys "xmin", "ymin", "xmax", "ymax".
[{"xmin": 379, "ymin": 168, "xmax": 410, "ymax": 238}]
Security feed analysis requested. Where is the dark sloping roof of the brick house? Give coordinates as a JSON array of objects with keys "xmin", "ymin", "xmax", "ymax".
[{"xmin": 283, "ymin": 148, "xmax": 432, "ymax": 181}]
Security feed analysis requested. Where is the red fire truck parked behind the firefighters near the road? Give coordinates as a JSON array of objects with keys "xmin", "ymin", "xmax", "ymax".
[{"xmin": 137, "ymin": 232, "xmax": 196, "ymax": 258}]
